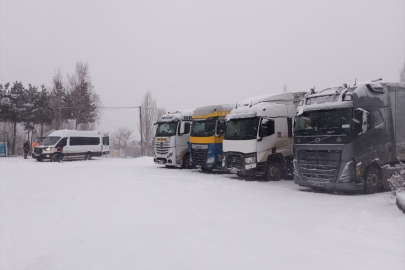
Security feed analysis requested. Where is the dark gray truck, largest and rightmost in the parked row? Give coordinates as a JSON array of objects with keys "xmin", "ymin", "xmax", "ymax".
[{"xmin": 294, "ymin": 82, "xmax": 405, "ymax": 193}]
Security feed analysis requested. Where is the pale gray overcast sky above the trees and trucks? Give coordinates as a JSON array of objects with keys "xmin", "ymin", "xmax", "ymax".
[{"xmin": 0, "ymin": 0, "xmax": 405, "ymax": 137}]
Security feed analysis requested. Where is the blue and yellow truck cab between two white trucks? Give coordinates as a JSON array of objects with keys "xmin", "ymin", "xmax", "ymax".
[{"xmin": 189, "ymin": 104, "xmax": 234, "ymax": 171}]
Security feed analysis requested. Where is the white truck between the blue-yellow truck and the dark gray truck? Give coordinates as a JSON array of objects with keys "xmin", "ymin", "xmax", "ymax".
[{"xmin": 222, "ymin": 92, "xmax": 306, "ymax": 180}]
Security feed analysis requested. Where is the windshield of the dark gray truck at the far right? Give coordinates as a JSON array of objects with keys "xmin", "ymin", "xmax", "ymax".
[{"xmin": 295, "ymin": 108, "xmax": 354, "ymax": 136}]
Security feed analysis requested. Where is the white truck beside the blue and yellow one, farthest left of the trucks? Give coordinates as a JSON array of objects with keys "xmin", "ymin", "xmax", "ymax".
[{"xmin": 153, "ymin": 110, "xmax": 194, "ymax": 168}]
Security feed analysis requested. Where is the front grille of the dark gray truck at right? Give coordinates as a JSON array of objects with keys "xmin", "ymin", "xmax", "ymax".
[{"xmin": 298, "ymin": 150, "xmax": 340, "ymax": 181}]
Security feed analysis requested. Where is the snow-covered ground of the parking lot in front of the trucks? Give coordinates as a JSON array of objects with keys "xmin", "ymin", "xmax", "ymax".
[{"xmin": 0, "ymin": 158, "xmax": 405, "ymax": 270}]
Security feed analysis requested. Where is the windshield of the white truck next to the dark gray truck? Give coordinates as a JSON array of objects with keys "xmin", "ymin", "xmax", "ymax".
[{"xmin": 224, "ymin": 117, "xmax": 259, "ymax": 140}]
